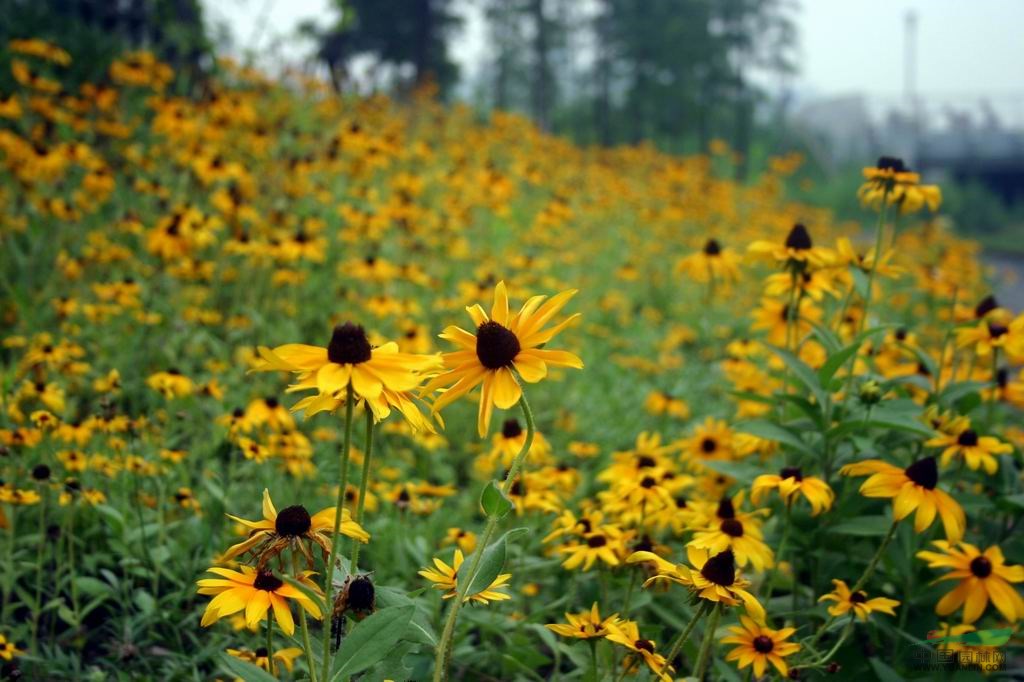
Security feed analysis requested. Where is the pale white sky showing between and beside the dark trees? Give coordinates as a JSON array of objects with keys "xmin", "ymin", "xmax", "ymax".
[{"xmin": 203, "ymin": 0, "xmax": 1024, "ymax": 98}]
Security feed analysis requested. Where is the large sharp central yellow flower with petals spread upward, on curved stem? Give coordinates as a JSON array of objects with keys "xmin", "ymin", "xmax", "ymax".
[{"xmin": 424, "ymin": 282, "xmax": 583, "ymax": 438}]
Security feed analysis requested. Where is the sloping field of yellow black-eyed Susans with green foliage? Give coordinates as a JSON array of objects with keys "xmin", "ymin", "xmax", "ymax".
[{"xmin": 0, "ymin": 40, "xmax": 1024, "ymax": 682}]
